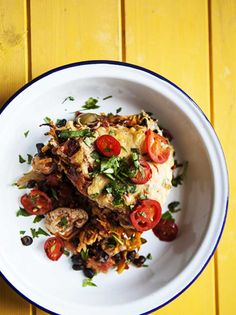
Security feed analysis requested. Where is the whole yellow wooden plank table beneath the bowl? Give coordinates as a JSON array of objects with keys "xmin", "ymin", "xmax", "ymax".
[{"xmin": 0, "ymin": 0, "xmax": 236, "ymax": 315}]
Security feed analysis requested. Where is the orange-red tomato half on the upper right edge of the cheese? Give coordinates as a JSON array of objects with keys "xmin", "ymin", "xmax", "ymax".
[{"xmin": 145, "ymin": 129, "xmax": 170, "ymax": 164}]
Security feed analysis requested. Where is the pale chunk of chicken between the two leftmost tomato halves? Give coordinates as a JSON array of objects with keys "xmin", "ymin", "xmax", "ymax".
[{"xmin": 45, "ymin": 208, "xmax": 88, "ymax": 240}]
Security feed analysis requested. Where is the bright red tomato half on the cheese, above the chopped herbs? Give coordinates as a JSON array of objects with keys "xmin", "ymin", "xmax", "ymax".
[{"xmin": 95, "ymin": 135, "xmax": 121, "ymax": 157}]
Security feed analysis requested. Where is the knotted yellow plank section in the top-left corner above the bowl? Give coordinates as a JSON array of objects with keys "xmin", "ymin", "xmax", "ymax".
[{"xmin": 0, "ymin": 0, "xmax": 27, "ymax": 106}]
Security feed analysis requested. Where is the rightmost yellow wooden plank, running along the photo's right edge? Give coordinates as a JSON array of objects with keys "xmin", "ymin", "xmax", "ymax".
[{"xmin": 211, "ymin": 0, "xmax": 236, "ymax": 315}]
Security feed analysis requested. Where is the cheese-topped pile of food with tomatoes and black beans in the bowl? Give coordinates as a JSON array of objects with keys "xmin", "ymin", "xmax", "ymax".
[{"xmin": 17, "ymin": 107, "xmax": 183, "ymax": 286}]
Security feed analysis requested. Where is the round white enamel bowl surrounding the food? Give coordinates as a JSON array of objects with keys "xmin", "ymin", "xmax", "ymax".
[{"xmin": 0, "ymin": 61, "xmax": 228, "ymax": 315}]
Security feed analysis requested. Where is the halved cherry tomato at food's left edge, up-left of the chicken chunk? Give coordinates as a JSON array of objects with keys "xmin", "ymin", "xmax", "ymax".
[{"xmin": 20, "ymin": 189, "xmax": 52, "ymax": 215}]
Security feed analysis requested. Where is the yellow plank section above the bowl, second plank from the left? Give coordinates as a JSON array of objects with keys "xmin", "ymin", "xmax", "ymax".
[{"xmin": 31, "ymin": 0, "xmax": 120, "ymax": 77}]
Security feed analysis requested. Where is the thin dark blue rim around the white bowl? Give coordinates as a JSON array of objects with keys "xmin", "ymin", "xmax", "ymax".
[{"xmin": 0, "ymin": 60, "xmax": 229, "ymax": 315}]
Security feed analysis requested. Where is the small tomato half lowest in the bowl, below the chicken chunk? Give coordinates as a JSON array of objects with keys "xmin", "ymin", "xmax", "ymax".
[{"xmin": 44, "ymin": 237, "xmax": 64, "ymax": 261}]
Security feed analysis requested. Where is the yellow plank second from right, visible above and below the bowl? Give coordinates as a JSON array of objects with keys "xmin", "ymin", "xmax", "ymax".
[{"xmin": 125, "ymin": 0, "xmax": 215, "ymax": 315}]
